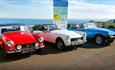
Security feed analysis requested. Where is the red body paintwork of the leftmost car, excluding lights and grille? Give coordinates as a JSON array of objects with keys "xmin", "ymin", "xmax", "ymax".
[{"xmin": 0, "ymin": 31, "xmax": 44, "ymax": 51}]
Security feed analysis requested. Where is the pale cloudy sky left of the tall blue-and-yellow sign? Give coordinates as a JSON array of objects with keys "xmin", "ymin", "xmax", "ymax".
[{"xmin": 0, "ymin": 0, "xmax": 53, "ymax": 19}]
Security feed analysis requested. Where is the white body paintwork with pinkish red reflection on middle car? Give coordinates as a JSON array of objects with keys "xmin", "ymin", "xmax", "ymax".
[{"xmin": 34, "ymin": 29, "xmax": 86, "ymax": 46}]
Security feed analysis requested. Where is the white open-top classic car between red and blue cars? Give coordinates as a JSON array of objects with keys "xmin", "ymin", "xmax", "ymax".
[{"xmin": 33, "ymin": 24, "xmax": 87, "ymax": 50}]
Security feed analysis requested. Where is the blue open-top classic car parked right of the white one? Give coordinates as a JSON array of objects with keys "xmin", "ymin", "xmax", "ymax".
[{"xmin": 68, "ymin": 23, "xmax": 115, "ymax": 45}]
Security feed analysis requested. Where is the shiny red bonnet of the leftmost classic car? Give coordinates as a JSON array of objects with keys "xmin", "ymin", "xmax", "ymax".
[{"xmin": 3, "ymin": 31, "xmax": 36, "ymax": 44}]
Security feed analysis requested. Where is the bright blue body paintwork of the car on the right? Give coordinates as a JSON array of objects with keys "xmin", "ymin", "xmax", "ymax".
[{"xmin": 68, "ymin": 23, "xmax": 115, "ymax": 39}]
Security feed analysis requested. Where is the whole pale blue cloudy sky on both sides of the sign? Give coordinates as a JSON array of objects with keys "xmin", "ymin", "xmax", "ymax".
[{"xmin": 0, "ymin": 0, "xmax": 115, "ymax": 19}]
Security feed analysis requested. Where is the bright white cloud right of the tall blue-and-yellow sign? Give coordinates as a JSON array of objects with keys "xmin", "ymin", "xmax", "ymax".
[{"xmin": 69, "ymin": 0, "xmax": 115, "ymax": 19}]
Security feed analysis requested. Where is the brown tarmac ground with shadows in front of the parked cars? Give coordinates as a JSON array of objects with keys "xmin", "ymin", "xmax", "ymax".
[{"xmin": 0, "ymin": 42, "xmax": 115, "ymax": 70}]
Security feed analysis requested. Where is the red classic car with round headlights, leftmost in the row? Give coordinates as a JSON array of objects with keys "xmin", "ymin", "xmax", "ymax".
[{"xmin": 0, "ymin": 25, "xmax": 44, "ymax": 55}]
